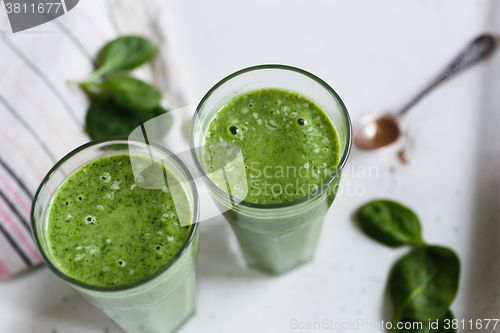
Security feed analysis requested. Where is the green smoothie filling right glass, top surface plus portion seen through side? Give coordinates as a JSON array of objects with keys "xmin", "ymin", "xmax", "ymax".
[{"xmin": 204, "ymin": 89, "xmax": 341, "ymax": 274}]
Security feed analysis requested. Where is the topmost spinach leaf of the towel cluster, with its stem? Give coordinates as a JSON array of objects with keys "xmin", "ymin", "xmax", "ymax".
[{"xmin": 86, "ymin": 36, "xmax": 156, "ymax": 83}]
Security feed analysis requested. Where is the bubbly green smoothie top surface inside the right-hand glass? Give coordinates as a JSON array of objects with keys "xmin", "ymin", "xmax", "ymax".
[{"xmin": 205, "ymin": 89, "xmax": 340, "ymax": 204}]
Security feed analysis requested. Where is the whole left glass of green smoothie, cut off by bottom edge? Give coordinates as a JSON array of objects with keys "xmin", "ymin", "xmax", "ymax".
[{"xmin": 31, "ymin": 137, "xmax": 199, "ymax": 333}]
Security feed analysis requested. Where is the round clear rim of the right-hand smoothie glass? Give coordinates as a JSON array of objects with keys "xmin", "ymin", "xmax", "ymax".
[{"xmin": 189, "ymin": 64, "xmax": 353, "ymax": 209}]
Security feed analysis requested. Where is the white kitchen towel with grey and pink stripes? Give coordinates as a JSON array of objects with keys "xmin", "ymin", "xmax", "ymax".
[{"xmin": 0, "ymin": 0, "xmax": 185, "ymax": 278}]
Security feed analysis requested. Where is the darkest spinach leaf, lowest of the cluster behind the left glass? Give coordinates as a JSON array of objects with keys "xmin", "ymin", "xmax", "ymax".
[{"xmin": 85, "ymin": 95, "xmax": 168, "ymax": 140}]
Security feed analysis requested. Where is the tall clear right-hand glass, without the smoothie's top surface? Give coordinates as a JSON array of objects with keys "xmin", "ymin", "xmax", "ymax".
[{"xmin": 190, "ymin": 65, "xmax": 352, "ymax": 274}]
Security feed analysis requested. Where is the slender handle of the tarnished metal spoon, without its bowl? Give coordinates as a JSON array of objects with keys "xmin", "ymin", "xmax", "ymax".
[{"xmin": 397, "ymin": 34, "xmax": 497, "ymax": 116}]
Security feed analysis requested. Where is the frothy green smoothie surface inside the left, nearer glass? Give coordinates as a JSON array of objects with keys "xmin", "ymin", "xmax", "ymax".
[{"xmin": 47, "ymin": 154, "xmax": 191, "ymax": 287}]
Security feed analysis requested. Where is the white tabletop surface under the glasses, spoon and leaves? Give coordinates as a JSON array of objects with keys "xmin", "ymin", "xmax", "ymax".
[{"xmin": 0, "ymin": 0, "xmax": 500, "ymax": 333}]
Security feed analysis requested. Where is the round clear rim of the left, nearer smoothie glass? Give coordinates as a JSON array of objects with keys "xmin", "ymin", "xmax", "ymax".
[{"xmin": 30, "ymin": 136, "xmax": 199, "ymax": 292}]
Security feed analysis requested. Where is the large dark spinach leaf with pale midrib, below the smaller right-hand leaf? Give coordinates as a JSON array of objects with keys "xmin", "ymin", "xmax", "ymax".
[{"xmin": 388, "ymin": 246, "xmax": 460, "ymax": 323}]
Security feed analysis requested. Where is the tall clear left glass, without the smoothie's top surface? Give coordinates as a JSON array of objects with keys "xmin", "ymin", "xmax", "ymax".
[{"xmin": 31, "ymin": 137, "xmax": 199, "ymax": 333}]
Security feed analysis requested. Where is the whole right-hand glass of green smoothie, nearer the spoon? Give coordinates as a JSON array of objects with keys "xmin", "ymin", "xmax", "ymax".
[{"xmin": 190, "ymin": 65, "xmax": 352, "ymax": 274}]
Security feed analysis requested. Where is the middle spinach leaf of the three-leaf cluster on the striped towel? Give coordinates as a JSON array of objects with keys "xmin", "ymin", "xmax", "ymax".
[{"xmin": 100, "ymin": 76, "xmax": 161, "ymax": 111}]
